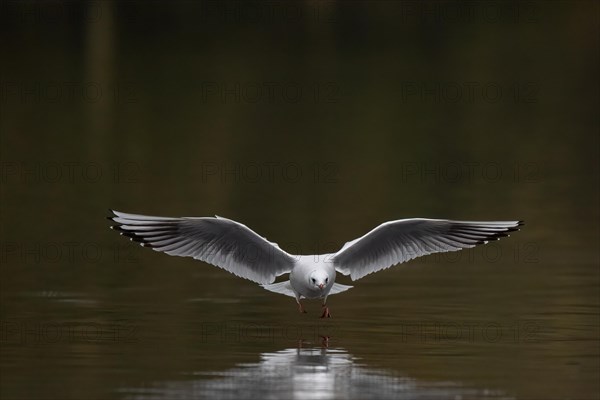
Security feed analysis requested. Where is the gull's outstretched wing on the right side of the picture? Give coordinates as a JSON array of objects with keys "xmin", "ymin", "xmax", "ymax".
[{"xmin": 332, "ymin": 218, "xmax": 523, "ymax": 280}]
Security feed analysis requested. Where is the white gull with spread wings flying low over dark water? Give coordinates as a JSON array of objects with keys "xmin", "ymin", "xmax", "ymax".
[{"xmin": 108, "ymin": 210, "xmax": 523, "ymax": 318}]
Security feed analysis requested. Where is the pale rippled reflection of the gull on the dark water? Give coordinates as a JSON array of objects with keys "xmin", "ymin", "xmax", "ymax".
[{"xmin": 123, "ymin": 344, "xmax": 509, "ymax": 400}]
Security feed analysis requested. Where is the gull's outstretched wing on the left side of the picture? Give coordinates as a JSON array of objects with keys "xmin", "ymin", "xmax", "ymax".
[{"xmin": 109, "ymin": 210, "xmax": 295, "ymax": 284}]
